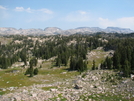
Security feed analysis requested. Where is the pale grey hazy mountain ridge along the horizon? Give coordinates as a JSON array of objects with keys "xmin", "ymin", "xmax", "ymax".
[{"xmin": 0, "ymin": 27, "xmax": 134, "ymax": 35}]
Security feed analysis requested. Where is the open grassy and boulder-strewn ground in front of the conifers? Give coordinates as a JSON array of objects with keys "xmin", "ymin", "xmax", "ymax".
[{"xmin": 0, "ymin": 48, "xmax": 134, "ymax": 101}]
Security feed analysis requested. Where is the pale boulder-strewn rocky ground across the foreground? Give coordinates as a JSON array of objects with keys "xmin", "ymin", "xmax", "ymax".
[{"xmin": 0, "ymin": 70, "xmax": 134, "ymax": 101}]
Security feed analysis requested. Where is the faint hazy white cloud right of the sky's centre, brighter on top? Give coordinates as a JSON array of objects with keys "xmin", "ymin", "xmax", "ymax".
[{"xmin": 65, "ymin": 11, "xmax": 91, "ymax": 22}]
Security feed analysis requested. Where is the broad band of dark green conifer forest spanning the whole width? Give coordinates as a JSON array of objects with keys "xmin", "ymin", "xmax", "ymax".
[{"xmin": 0, "ymin": 32, "xmax": 134, "ymax": 76}]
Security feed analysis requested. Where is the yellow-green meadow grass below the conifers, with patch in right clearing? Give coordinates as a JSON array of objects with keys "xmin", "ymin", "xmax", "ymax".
[{"xmin": 0, "ymin": 50, "xmax": 105, "ymax": 95}]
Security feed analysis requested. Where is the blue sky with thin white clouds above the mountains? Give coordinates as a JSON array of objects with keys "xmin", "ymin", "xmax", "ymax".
[{"xmin": 0, "ymin": 0, "xmax": 134, "ymax": 30}]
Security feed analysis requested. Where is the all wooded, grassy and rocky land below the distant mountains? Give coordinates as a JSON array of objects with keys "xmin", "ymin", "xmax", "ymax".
[{"xmin": 0, "ymin": 34, "xmax": 134, "ymax": 101}]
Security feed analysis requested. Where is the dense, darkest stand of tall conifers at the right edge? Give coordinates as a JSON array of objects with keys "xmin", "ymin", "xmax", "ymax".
[{"xmin": 101, "ymin": 38, "xmax": 134, "ymax": 77}]
